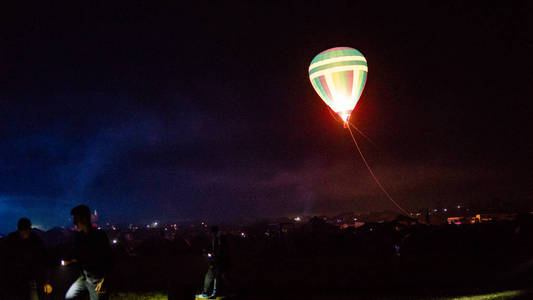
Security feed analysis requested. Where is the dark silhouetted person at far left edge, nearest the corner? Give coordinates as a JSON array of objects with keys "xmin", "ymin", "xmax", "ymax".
[{"xmin": 2, "ymin": 218, "xmax": 51, "ymax": 300}]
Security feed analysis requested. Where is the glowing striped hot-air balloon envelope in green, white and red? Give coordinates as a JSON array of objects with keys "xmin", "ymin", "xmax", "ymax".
[{"xmin": 309, "ymin": 47, "xmax": 368, "ymax": 122}]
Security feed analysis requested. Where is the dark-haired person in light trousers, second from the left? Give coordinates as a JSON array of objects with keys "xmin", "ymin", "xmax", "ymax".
[{"xmin": 64, "ymin": 205, "xmax": 113, "ymax": 300}]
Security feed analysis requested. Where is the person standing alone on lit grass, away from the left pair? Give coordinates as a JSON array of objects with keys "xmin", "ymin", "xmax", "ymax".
[{"xmin": 197, "ymin": 226, "xmax": 228, "ymax": 299}]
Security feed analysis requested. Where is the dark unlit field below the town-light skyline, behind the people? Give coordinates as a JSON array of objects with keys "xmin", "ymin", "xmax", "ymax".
[{"xmin": 1, "ymin": 217, "xmax": 533, "ymax": 299}]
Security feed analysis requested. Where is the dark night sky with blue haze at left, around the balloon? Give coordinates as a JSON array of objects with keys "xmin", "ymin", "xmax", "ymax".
[{"xmin": 0, "ymin": 1, "xmax": 533, "ymax": 233}]
